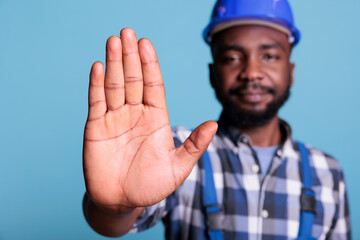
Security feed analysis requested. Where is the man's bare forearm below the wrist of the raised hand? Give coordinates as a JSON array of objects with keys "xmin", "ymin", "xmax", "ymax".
[{"xmin": 83, "ymin": 193, "xmax": 143, "ymax": 237}]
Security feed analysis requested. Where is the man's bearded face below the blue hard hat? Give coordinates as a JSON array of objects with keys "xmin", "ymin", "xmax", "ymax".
[{"xmin": 211, "ymin": 26, "xmax": 294, "ymax": 128}]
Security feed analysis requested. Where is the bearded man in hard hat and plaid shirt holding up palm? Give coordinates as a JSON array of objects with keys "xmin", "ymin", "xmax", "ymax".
[{"xmin": 84, "ymin": 0, "xmax": 350, "ymax": 239}]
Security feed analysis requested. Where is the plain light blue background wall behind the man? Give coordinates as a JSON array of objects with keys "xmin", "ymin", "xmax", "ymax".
[{"xmin": 0, "ymin": 0, "xmax": 360, "ymax": 239}]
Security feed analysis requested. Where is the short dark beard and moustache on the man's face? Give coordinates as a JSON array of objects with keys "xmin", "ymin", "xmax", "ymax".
[{"xmin": 215, "ymin": 78, "xmax": 290, "ymax": 129}]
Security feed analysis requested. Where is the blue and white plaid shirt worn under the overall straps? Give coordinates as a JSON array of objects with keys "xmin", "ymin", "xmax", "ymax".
[{"xmin": 131, "ymin": 121, "xmax": 351, "ymax": 240}]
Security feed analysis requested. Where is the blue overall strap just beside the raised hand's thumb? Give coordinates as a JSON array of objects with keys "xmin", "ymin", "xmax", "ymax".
[{"xmin": 202, "ymin": 151, "xmax": 224, "ymax": 240}]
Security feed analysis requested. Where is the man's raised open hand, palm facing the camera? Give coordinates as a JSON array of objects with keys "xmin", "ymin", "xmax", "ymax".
[{"xmin": 83, "ymin": 28, "xmax": 217, "ymax": 208}]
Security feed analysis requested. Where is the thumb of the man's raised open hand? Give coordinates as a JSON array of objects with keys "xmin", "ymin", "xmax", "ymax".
[{"xmin": 173, "ymin": 121, "xmax": 218, "ymax": 185}]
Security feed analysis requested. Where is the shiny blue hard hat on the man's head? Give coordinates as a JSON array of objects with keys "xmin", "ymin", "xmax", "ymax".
[{"xmin": 203, "ymin": 0, "xmax": 300, "ymax": 46}]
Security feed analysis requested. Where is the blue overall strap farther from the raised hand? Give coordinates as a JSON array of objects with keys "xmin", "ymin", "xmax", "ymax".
[{"xmin": 297, "ymin": 142, "xmax": 316, "ymax": 240}]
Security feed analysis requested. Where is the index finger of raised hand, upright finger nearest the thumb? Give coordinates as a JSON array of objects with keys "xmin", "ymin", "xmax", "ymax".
[{"xmin": 139, "ymin": 38, "xmax": 166, "ymax": 108}]
